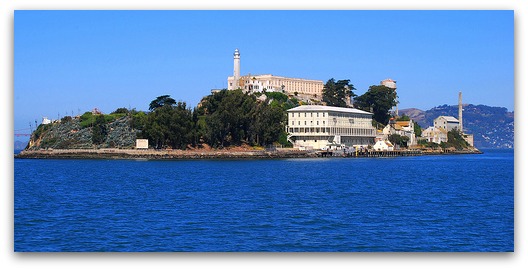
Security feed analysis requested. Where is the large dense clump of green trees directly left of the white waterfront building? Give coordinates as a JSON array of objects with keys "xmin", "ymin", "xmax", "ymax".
[{"xmin": 197, "ymin": 90, "xmax": 288, "ymax": 147}]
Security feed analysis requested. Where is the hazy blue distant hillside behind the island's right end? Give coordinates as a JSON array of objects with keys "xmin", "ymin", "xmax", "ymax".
[{"xmin": 399, "ymin": 104, "xmax": 514, "ymax": 149}]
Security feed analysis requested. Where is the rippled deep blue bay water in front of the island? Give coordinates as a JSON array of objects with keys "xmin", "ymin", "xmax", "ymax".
[{"xmin": 14, "ymin": 150, "xmax": 514, "ymax": 252}]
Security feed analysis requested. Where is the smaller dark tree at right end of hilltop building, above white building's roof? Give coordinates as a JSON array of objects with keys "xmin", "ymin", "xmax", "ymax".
[{"xmin": 323, "ymin": 78, "xmax": 356, "ymax": 107}]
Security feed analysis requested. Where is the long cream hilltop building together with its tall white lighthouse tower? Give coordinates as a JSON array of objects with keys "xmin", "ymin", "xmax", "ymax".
[{"xmin": 227, "ymin": 49, "xmax": 324, "ymax": 99}]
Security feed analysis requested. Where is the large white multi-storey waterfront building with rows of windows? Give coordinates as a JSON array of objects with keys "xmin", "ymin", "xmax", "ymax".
[{"xmin": 287, "ymin": 105, "xmax": 376, "ymax": 149}]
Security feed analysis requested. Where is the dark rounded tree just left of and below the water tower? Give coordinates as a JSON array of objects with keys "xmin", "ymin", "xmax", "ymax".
[{"xmin": 354, "ymin": 85, "xmax": 396, "ymax": 125}]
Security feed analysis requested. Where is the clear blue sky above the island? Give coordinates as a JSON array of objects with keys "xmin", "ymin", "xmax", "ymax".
[{"xmin": 13, "ymin": 11, "xmax": 514, "ymax": 131}]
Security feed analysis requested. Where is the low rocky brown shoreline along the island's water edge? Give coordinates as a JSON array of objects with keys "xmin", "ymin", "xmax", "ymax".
[{"xmin": 15, "ymin": 148, "xmax": 482, "ymax": 160}]
